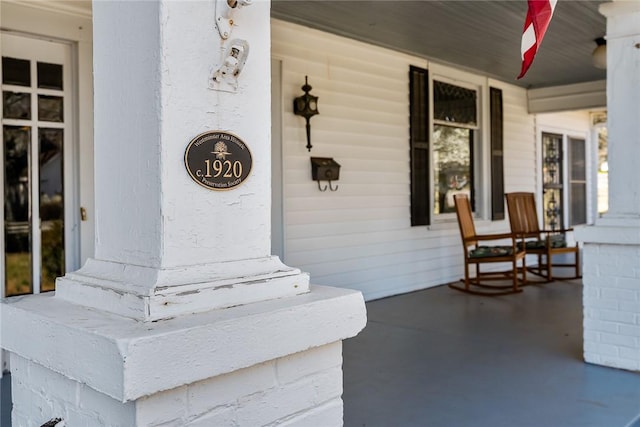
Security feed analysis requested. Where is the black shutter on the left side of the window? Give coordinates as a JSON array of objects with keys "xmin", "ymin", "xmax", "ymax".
[{"xmin": 409, "ymin": 66, "xmax": 430, "ymax": 226}]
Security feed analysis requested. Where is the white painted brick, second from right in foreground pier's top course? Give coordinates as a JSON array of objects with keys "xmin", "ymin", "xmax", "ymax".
[{"xmin": 187, "ymin": 361, "xmax": 277, "ymax": 416}]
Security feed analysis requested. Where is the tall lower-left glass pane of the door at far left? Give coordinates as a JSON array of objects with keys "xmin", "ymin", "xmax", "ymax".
[{"xmin": 3, "ymin": 126, "xmax": 33, "ymax": 296}]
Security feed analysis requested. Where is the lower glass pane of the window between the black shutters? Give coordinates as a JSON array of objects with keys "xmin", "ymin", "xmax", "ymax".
[{"xmin": 433, "ymin": 125, "xmax": 473, "ymax": 214}]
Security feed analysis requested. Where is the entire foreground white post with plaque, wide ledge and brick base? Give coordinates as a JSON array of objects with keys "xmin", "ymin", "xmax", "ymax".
[{"xmin": 1, "ymin": 0, "xmax": 366, "ymax": 426}]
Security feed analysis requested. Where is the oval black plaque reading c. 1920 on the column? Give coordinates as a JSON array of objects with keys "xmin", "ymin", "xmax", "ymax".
[{"xmin": 184, "ymin": 131, "xmax": 253, "ymax": 190}]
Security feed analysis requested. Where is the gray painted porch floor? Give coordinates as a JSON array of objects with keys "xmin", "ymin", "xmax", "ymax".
[{"xmin": 344, "ymin": 281, "xmax": 640, "ymax": 427}]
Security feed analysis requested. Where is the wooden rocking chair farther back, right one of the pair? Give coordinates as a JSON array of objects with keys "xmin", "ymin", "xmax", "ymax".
[{"xmin": 506, "ymin": 192, "xmax": 581, "ymax": 282}]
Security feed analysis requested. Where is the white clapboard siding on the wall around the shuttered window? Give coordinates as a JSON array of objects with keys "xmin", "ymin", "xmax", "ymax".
[{"xmin": 272, "ymin": 20, "xmax": 536, "ymax": 299}]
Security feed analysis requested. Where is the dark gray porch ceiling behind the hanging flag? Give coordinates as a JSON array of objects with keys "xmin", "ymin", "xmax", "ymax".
[{"xmin": 271, "ymin": 0, "xmax": 606, "ymax": 88}]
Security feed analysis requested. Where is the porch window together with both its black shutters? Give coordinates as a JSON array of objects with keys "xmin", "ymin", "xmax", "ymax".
[{"xmin": 409, "ymin": 67, "xmax": 504, "ymax": 226}]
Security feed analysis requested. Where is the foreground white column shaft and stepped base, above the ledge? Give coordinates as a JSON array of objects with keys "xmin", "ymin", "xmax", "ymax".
[{"xmin": 49, "ymin": 0, "xmax": 309, "ymax": 320}]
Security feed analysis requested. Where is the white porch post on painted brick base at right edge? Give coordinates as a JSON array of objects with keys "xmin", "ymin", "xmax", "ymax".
[{"xmin": 575, "ymin": 1, "xmax": 640, "ymax": 370}]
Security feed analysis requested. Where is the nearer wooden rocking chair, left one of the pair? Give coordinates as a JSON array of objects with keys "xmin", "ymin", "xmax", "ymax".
[{"xmin": 449, "ymin": 194, "xmax": 527, "ymax": 296}]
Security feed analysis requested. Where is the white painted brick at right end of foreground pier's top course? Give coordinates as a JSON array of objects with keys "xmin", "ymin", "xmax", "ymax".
[{"xmin": 276, "ymin": 342, "xmax": 342, "ymax": 384}]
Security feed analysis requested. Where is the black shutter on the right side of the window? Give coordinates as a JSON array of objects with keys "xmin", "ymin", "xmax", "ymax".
[{"xmin": 490, "ymin": 87, "xmax": 504, "ymax": 220}]
